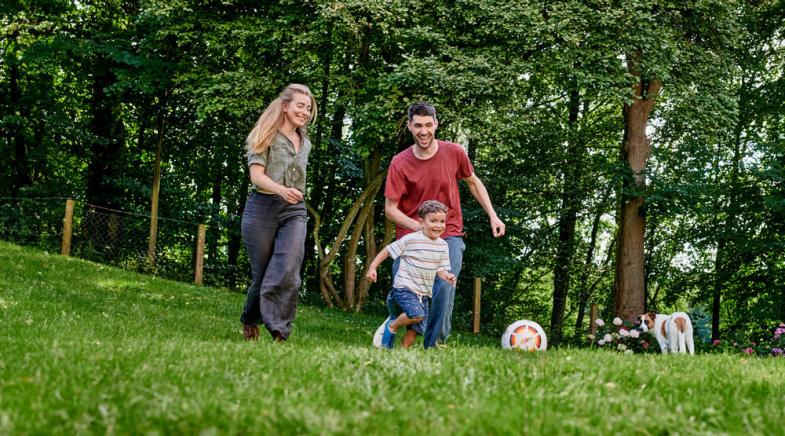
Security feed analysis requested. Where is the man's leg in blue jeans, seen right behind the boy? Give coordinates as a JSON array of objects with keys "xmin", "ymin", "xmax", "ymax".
[{"xmin": 423, "ymin": 236, "xmax": 466, "ymax": 348}]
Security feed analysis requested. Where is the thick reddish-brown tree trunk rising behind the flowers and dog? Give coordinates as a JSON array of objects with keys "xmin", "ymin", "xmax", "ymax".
[{"xmin": 613, "ymin": 56, "xmax": 662, "ymax": 320}]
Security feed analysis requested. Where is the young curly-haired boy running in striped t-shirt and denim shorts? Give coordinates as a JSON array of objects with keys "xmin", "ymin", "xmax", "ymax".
[{"xmin": 365, "ymin": 200, "xmax": 456, "ymax": 348}]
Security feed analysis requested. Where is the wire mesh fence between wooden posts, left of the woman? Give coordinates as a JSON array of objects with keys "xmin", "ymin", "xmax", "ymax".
[{"xmin": 0, "ymin": 197, "xmax": 249, "ymax": 291}]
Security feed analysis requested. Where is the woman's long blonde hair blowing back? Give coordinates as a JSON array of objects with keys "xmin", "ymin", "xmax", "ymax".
[{"xmin": 245, "ymin": 83, "xmax": 316, "ymax": 154}]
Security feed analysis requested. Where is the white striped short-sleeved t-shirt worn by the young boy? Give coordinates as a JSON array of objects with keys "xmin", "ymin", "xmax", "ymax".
[{"xmin": 387, "ymin": 230, "xmax": 450, "ymax": 297}]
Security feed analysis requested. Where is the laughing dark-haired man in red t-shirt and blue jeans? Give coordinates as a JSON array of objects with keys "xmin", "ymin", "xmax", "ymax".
[{"xmin": 384, "ymin": 102, "xmax": 505, "ymax": 348}]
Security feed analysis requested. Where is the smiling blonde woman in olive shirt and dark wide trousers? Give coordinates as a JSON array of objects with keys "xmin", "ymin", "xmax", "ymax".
[{"xmin": 240, "ymin": 84, "xmax": 316, "ymax": 341}]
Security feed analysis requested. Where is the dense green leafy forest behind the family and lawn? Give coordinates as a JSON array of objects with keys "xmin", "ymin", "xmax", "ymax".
[{"xmin": 0, "ymin": 0, "xmax": 785, "ymax": 343}]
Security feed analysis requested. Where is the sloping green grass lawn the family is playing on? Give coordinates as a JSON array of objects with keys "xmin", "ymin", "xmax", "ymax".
[{"xmin": 0, "ymin": 242, "xmax": 785, "ymax": 434}]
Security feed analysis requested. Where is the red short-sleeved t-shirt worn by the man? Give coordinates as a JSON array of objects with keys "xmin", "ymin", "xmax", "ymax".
[{"xmin": 384, "ymin": 141, "xmax": 474, "ymax": 239}]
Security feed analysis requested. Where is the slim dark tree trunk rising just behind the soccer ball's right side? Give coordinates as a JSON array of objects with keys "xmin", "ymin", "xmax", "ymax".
[{"xmin": 550, "ymin": 84, "xmax": 583, "ymax": 346}]
